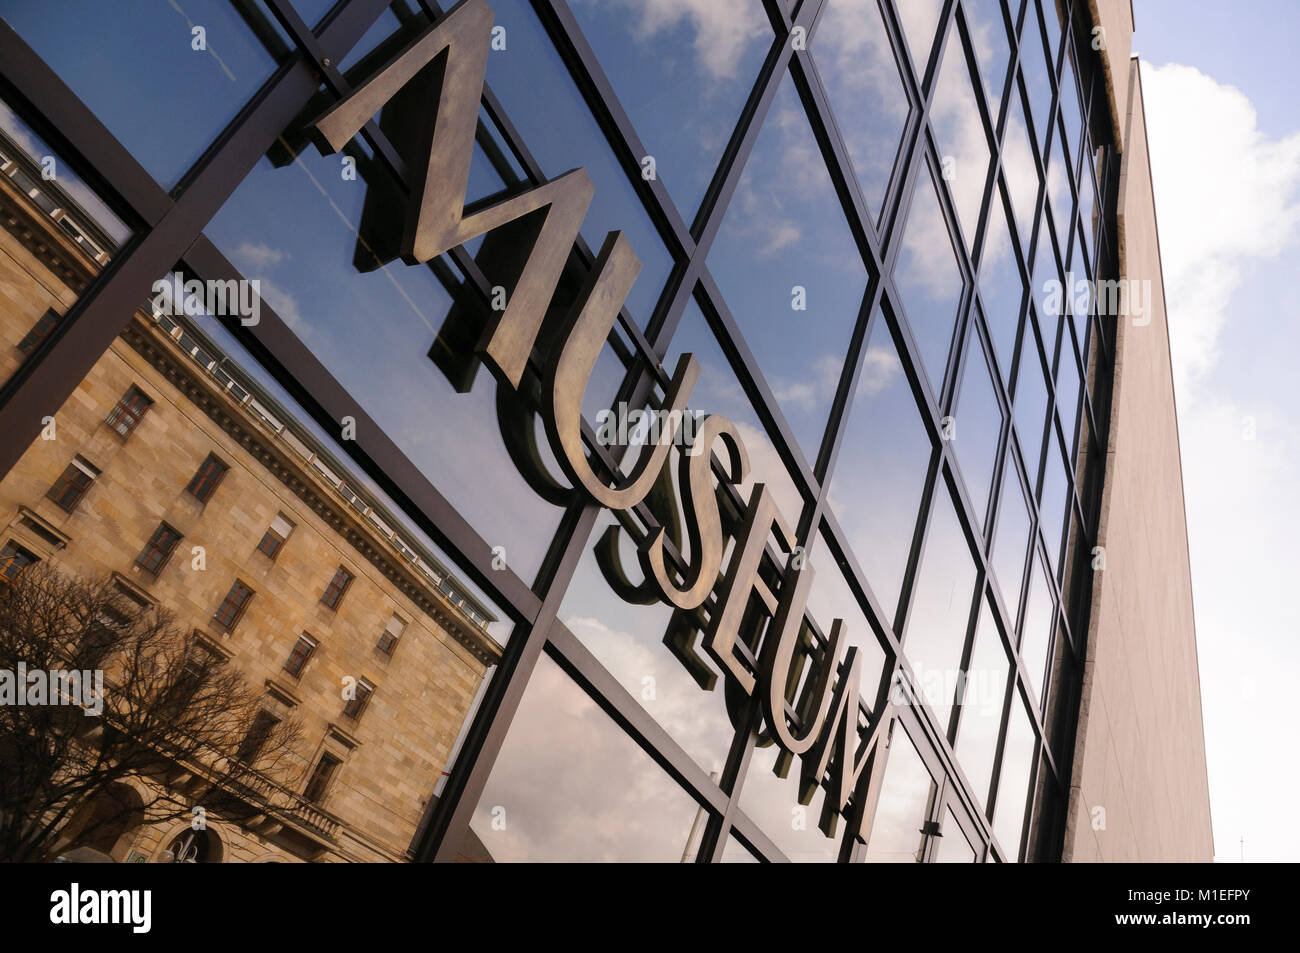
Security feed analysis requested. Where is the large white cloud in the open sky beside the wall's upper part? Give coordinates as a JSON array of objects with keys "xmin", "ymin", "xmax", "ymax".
[{"xmin": 1143, "ymin": 64, "xmax": 1300, "ymax": 395}]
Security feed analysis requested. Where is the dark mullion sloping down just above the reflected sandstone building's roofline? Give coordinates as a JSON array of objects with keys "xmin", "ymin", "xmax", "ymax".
[{"xmin": 185, "ymin": 237, "xmax": 541, "ymax": 621}]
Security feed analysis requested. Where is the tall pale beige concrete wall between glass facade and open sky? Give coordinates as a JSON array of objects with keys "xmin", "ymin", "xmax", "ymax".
[{"xmin": 1063, "ymin": 52, "xmax": 1214, "ymax": 861}]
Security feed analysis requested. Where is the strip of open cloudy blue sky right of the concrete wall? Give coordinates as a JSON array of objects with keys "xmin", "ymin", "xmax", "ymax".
[{"xmin": 1134, "ymin": 0, "xmax": 1300, "ymax": 862}]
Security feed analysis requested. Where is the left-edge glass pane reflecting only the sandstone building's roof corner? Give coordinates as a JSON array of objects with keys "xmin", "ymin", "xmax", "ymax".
[{"xmin": 0, "ymin": 100, "xmax": 130, "ymax": 384}]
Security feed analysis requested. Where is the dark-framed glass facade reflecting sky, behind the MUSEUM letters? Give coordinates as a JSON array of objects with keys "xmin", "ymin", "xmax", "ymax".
[{"xmin": 0, "ymin": 0, "xmax": 1118, "ymax": 862}]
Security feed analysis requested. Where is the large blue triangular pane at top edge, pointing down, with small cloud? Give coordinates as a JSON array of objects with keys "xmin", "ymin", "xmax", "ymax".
[{"xmin": 569, "ymin": 0, "xmax": 772, "ymax": 222}]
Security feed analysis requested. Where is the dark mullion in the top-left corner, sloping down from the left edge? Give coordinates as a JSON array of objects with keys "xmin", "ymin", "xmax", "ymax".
[{"xmin": 0, "ymin": 18, "xmax": 173, "ymax": 228}]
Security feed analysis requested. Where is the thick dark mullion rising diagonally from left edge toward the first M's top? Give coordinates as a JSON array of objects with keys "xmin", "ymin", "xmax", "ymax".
[{"xmin": 0, "ymin": 7, "xmax": 390, "ymax": 477}]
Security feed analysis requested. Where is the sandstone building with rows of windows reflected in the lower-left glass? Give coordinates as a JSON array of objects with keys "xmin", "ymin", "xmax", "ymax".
[{"xmin": 0, "ymin": 126, "xmax": 501, "ymax": 862}]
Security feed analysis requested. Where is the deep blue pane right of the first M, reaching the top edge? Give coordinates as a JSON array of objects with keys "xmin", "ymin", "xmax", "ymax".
[{"xmin": 488, "ymin": 0, "xmax": 672, "ymax": 326}]
